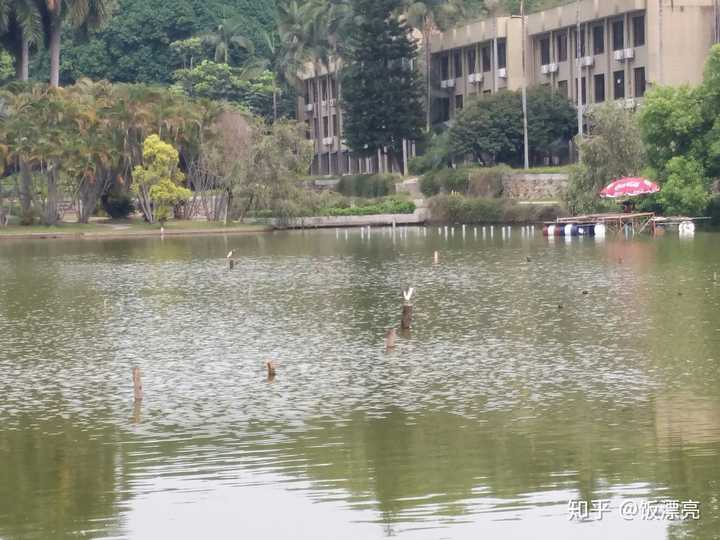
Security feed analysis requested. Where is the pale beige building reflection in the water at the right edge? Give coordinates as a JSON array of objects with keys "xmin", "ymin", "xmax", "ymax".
[{"xmin": 655, "ymin": 394, "xmax": 720, "ymax": 446}]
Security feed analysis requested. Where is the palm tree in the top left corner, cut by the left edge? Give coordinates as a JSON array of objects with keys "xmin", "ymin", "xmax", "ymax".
[{"xmin": 0, "ymin": 0, "xmax": 42, "ymax": 81}]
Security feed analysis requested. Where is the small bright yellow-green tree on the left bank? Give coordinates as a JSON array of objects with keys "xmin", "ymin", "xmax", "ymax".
[{"xmin": 132, "ymin": 135, "xmax": 192, "ymax": 223}]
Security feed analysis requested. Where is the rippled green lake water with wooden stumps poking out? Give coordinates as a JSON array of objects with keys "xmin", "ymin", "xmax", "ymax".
[{"xmin": 0, "ymin": 227, "xmax": 720, "ymax": 540}]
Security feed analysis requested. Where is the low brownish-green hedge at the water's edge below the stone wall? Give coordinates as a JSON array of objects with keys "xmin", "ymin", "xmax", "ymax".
[{"xmin": 428, "ymin": 193, "xmax": 567, "ymax": 224}]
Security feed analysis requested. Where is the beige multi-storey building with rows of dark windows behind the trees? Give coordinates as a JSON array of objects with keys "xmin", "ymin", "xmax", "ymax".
[{"xmin": 298, "ymin": 0, "xmax": 720, "ymax": 175}]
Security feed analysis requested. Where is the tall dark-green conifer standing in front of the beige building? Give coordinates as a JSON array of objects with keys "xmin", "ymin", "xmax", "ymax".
[{"xmin": 343, "ymin": 0, "xmax": 423, "ymax": 170}]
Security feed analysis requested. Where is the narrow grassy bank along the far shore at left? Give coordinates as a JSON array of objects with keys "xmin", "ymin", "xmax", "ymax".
[{"xmin": 0, "ymin": 219, "xmax": 271, "ymax": 239}]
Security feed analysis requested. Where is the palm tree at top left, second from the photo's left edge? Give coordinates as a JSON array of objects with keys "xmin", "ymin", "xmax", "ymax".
[{"xmin": 42, "ymin": 0, "xmax": 115, "ymax": 87}]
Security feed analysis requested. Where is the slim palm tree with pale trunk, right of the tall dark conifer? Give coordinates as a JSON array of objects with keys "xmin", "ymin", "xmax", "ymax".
[{"xmin": 407, "ymin": 0, "xmax": 464, "ymax": 131}]
